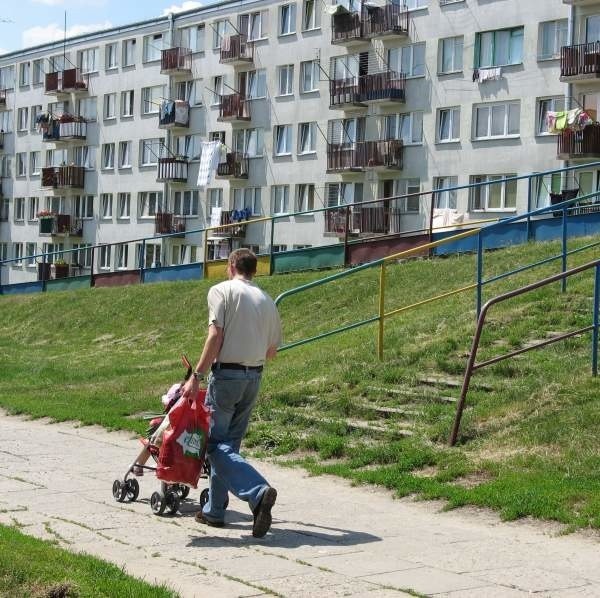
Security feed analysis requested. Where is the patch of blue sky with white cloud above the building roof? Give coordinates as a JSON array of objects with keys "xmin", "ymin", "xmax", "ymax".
[{"xmin": 0, "ymin": 0, "xmax": 210, "ymax": 54}]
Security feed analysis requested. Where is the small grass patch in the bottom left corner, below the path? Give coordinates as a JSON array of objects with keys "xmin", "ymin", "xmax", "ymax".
[{"xmin": 0, "ymin": 525, "xmax": 178, "ymax": 598}]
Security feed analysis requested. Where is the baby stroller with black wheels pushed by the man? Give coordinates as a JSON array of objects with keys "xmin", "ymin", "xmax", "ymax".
[{"xmin": 112, "ymin": 355, "xmax": 210, "ymax": 515}]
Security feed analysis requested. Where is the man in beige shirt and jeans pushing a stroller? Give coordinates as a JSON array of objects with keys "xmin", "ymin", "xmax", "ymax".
[{"xmin": 183, "ymin": 249, "xmax": 281, "ymax": 538}]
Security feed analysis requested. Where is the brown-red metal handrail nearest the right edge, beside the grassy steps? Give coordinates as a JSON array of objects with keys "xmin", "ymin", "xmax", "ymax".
[{"xmin": 449, "ymin": 260, "xmax": 600, "ymax": 446}]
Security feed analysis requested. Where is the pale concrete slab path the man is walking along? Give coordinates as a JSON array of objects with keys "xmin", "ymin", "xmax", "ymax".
[{"xmin": 0, "ymin": 413, "xmax": 600, "ymax": 598}]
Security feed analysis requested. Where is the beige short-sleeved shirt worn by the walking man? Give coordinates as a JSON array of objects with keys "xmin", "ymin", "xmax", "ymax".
[{"xmin": 207, "ymin": 278, "xmax": 281, "ymax": 366}]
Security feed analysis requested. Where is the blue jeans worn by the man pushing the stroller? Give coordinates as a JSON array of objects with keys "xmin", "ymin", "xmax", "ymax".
[{"xmin": 202, "ymin": 369, "xmax": 269, "ymax": 521}]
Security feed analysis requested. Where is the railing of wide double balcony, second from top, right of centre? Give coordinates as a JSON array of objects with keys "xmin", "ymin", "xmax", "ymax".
[{"xmin": 329, "ymin": 70, "xmax": 406, "ymax": 108}]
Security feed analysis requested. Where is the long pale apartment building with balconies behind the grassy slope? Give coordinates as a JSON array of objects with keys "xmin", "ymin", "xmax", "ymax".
[{"xmin": 0, "ymin": 0, "xmax": 576, "ymax": 284}]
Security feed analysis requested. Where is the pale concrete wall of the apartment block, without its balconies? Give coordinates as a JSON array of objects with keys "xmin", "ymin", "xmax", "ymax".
[{"xmin": 0, "ymin": 0, "xmax": 568, "ymax": 284}]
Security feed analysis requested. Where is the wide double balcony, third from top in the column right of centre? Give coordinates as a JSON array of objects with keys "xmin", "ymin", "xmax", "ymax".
[{"xmin": 327, "ymin": 139, "xmax": 403, "ymax": 172}]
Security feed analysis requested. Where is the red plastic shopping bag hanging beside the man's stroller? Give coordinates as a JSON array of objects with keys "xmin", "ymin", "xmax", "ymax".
[{"xmin": 156, "ymin": 389, "xmax": 210, "ymax": 488}]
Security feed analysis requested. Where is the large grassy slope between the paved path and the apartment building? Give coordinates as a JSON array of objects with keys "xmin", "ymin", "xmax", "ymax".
[{"xmin": 0, "ymin": 239, "xmax": 600, "ymax": 529}]
